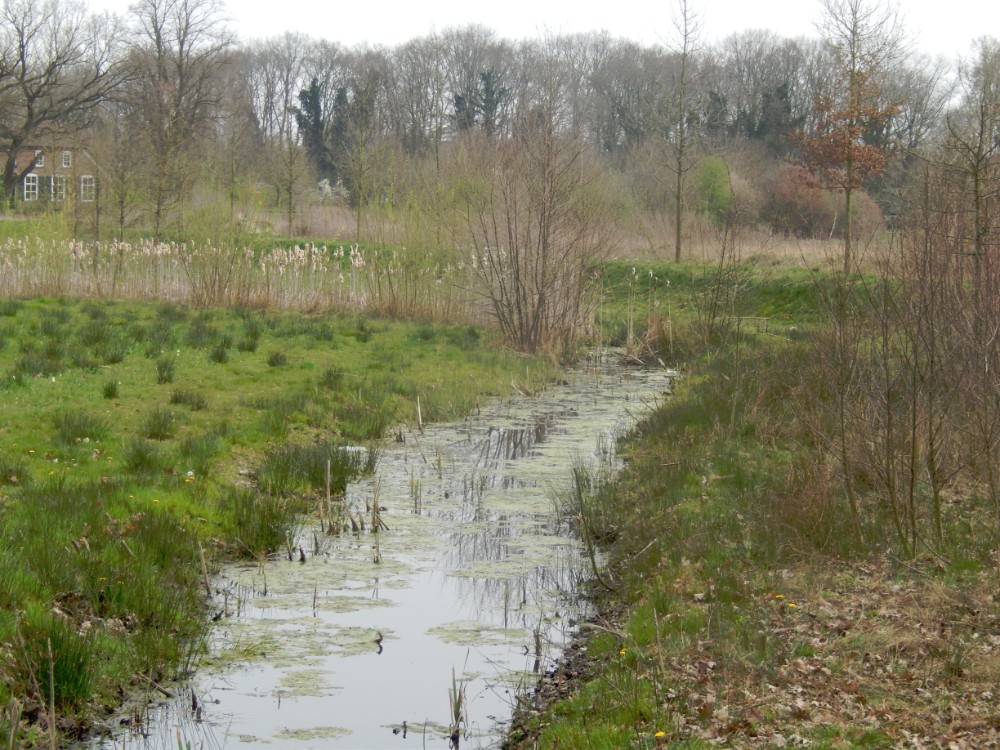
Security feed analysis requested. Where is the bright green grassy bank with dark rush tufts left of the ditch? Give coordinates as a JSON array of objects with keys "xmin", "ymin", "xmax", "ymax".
[{"xmin": 0, "ymin": 297, "xmax": 554, "ymax": 748}]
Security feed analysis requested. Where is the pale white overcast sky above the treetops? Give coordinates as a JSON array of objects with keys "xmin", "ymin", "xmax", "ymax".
[{"xmin": 89, "ymin": 0, "xmax": 1000, "ymax": 60}]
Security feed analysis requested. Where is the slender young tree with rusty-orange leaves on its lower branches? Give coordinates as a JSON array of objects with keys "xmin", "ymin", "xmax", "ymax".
[{"xmin": 796, "ymin": 0, "xmax": 904, "ymax": 273}]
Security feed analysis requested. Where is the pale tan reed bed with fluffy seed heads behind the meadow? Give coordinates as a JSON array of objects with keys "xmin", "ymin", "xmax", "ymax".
[{"xmin": 0, "ymin": 238, "xmax": 485, "ymax": 322}]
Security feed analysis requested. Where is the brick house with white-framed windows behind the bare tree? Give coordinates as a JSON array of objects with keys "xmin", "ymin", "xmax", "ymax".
[{"xmin": 6, "ymin": 147, "xmax": 98, "ymax": 203}]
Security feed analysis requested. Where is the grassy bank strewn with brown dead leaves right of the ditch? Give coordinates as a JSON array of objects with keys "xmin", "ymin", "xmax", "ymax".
[{"xmin": 510, "ymin": 266, "xmax": 1000, "ymax": 749}]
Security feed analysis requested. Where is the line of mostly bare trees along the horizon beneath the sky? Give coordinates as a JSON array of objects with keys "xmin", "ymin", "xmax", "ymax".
[{"xmin": 0, "ymin": 0, "xmax": 998, "ymax": 262}]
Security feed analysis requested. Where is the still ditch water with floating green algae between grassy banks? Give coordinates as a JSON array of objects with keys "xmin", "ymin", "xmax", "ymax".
[{"xmin": 101, "ymin": 356, "xmax": 672, "ymax": 750}]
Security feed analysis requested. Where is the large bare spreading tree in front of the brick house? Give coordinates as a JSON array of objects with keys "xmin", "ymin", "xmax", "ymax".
[{"xmin": 0, "ymin": 0, "xmax": 126, "ymax": 201}]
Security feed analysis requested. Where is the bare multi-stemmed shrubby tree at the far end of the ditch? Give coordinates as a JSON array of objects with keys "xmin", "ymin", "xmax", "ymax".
[{"xmin": 453, "ymin": 53, "xmax": 612, "ymax": 354}]
